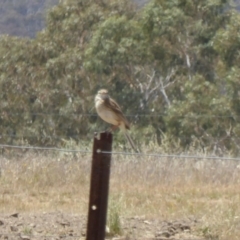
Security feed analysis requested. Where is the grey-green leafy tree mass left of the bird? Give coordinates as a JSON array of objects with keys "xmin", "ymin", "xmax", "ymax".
[{"xmin": 0, "ymin": 0, "xmax": 139, "ymax": 145}]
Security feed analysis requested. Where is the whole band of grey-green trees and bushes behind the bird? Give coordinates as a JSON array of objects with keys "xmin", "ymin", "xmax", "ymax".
[{"xmin": 0, "ymin": 0, "xmax": 240, "ymax": 155}]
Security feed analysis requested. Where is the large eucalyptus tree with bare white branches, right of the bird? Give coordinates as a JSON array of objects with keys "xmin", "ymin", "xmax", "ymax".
[{"xmin": 85, "ymin": 0, "xmax": 234, "ymax": 150}]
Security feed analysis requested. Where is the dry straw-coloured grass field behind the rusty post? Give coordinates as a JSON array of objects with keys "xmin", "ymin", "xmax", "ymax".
[{"xmin": 0, "ymin": 149, "xmax": 240, "ymax": 240}]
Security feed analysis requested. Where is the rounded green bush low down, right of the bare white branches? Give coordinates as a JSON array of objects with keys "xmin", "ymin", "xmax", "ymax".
[{"xmin": 165, "ymin": 75, "xmax": 233, "ymax": 150}]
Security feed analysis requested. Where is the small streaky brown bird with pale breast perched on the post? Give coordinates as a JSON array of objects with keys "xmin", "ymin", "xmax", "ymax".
[{"xmin": 95, "ymin": 89, "xmax": 138, "ymax": 152}]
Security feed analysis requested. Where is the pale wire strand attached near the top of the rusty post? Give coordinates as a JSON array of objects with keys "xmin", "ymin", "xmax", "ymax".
[{"xmin": 0, "ymin": 144, "xmax": 240, "ymax": 161}]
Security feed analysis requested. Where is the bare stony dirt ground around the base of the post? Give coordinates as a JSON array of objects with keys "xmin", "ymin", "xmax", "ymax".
[{"xmin": 0, "ymin": 212, "xmax": 204, "ymax": 240}]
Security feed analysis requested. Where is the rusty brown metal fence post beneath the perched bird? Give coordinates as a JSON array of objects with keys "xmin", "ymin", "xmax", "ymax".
[{"xmin": 86, "ymin": 132, "xmax": 112, "ymax": 240}]
